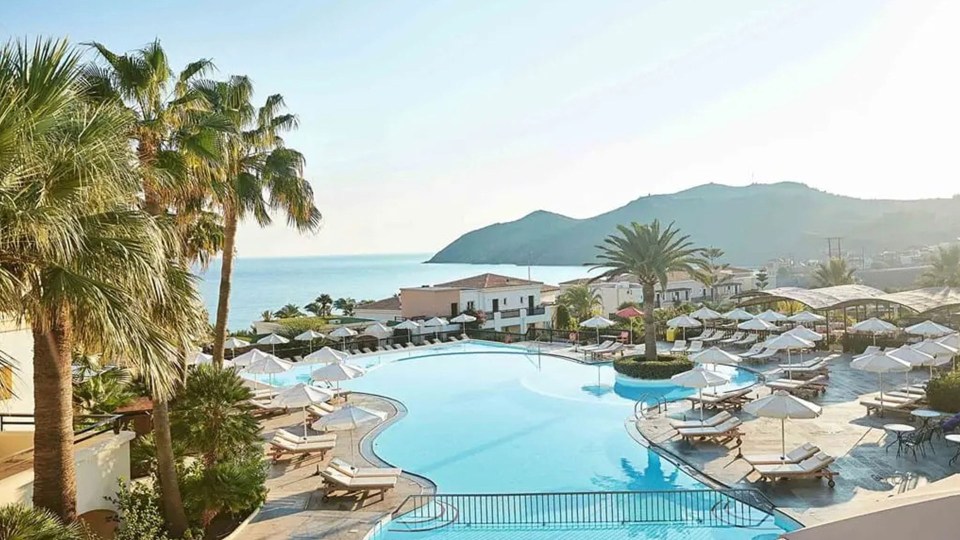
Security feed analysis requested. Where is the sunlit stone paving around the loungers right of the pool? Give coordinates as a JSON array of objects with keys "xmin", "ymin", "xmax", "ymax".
[{"xmin": 637, "ymin": 355, "xmax": 960, "ymax": 525}]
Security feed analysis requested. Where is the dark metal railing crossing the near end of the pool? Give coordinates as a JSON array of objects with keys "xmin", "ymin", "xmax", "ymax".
[{"xmin": 391, "ymin": 489, "xmax": 774, "ymax": 531}]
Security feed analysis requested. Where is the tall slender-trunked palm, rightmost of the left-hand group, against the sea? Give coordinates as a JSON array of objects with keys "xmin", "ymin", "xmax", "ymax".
[{"xmin": 203, "ymin": 76, "xmax": 320, "ymax": 365}]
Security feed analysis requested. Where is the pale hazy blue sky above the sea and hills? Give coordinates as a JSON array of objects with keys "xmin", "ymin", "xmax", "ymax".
[{"xmin": 0, "ymin": 0, "xmax": 960, "ymax": 257}]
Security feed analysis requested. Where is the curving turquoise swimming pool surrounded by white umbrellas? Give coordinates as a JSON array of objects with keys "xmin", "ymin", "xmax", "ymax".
[{"xmin": 251, "ymin": 342, "xmax": 783, "ymax": 540}]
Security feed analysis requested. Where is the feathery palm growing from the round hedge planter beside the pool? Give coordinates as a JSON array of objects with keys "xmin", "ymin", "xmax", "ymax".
[{"xmin": 594, "ymin": 220, "xmax": 706, "ymax": 360}]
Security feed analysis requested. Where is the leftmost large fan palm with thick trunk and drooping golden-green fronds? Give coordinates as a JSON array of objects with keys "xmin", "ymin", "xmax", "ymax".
[{"xmin": 0, "ymin": 40, "xmax": 184, "ymax": 521}]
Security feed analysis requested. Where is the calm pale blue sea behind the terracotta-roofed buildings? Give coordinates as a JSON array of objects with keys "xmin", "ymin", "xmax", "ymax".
[{"xmin": 200, "ymin": 253, "xmax": 590, "ymax": 330}]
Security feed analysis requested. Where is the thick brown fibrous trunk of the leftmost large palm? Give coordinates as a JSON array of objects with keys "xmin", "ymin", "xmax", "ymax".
[{"xmin": 31, "ymin": 312, "xmax": 77, "ymax": 523}]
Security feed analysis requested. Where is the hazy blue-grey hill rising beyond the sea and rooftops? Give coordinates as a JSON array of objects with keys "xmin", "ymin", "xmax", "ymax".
[{"xmin": 429, "ymin": 182, "xmax": 960, "ymax": 266}]
